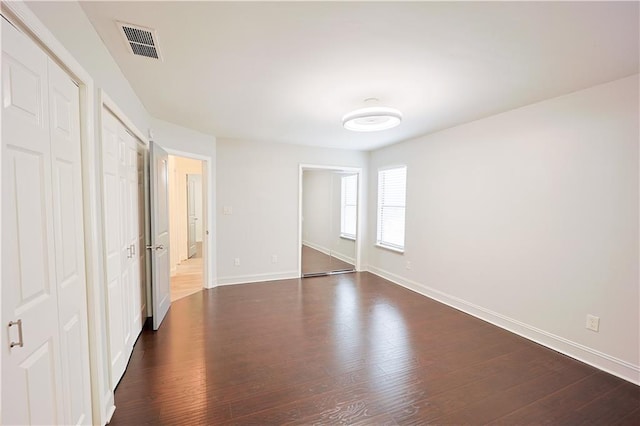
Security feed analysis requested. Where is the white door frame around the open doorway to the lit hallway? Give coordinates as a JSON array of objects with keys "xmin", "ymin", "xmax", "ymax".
[{"xmin": 162, "ymin": 146, "xmax": 216, "ymax": 288}]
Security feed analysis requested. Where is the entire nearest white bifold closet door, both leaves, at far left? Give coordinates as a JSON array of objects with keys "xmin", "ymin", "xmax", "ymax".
[{"xmin": 1, "ymin": 20, "xmax": 92, "ymax": 424}]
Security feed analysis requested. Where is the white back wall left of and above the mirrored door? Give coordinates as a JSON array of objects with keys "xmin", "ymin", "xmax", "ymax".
[{"xmin": 217, "ymin": 139, "xmax": 368, "ymax": 284}]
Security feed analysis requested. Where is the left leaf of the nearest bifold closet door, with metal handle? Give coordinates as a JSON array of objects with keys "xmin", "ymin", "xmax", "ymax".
[{"xmin": 2, "ymin": 21, "xmax": 64, "ymax": 424}]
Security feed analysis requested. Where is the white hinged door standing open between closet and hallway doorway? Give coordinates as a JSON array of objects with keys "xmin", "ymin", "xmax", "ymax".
[{"xmin": 149, "ymin": 142, "xmax": 171, "ymax": 330}]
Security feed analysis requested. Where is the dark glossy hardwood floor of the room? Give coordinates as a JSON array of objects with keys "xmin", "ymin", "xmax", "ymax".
[{"xmin": 111, "ymin": 273, "xmax": 640, "ymax": 425}]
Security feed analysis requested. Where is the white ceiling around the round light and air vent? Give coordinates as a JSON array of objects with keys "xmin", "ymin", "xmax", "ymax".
[{"xmin": 82, "ymin": 2, "xmax": 639, "ymax": 150}]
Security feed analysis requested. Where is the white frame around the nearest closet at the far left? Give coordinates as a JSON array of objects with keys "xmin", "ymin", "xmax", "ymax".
[{"xmin": 0, "ymin": 1, "xmax": 115, "ymax": 424}]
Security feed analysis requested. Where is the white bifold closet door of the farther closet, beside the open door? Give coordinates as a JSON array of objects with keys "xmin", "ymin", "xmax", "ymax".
[{"xmin": 102, "ymin": 108, "xmax": 146, "ymax": 387}]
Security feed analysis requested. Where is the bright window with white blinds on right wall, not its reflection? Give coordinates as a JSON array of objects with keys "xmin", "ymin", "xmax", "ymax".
[{"xmin": 376, "ymin": 166, "xmax": 407, "ymax": 251}]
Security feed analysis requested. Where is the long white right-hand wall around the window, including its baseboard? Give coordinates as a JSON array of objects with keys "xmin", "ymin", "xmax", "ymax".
[{"xmin": 368, "ymin": 75, "xmax": 640, "ymax": 382}]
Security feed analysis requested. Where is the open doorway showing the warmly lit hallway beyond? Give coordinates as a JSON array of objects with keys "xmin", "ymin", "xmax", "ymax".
[{"xmin": 169, "ymin": 155, "xmax": 204, "ymax": 302}]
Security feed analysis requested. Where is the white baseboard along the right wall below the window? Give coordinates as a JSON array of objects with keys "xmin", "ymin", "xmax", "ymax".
[{"xmin": 367, "ymin": 265, "xmax": 640, "ymax": 385}]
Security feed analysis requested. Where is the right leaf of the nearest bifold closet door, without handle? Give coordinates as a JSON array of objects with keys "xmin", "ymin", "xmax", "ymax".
[{"xmin": 49, "ymin": 55, "xmax": 91, "ymax": 424}]
